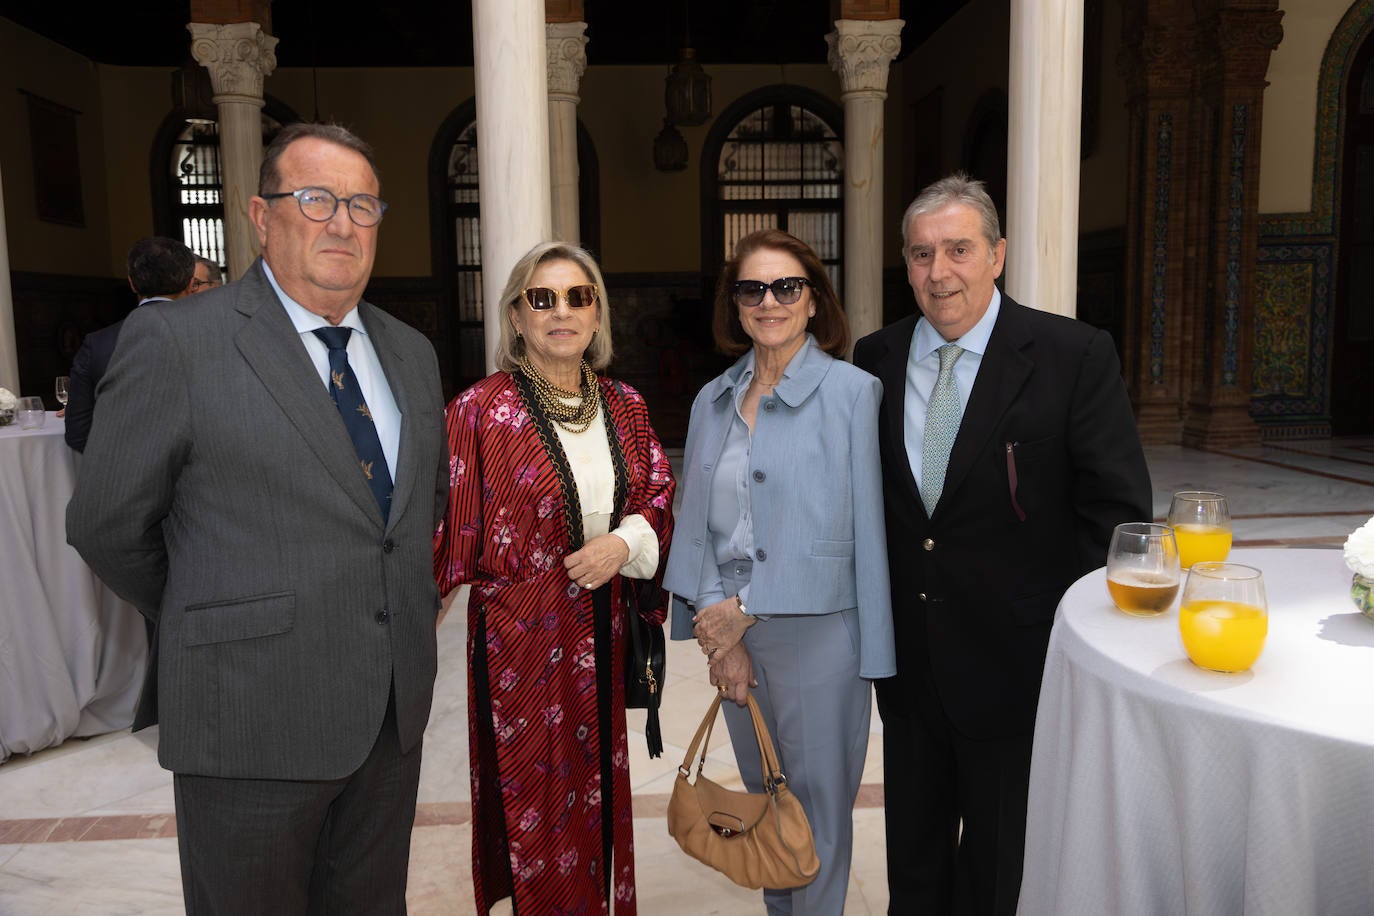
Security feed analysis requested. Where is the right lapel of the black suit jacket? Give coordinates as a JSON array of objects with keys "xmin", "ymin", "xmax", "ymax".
[{"xmin": 936, "ymin": 294, "xmax": 1035, "ymax": 512}]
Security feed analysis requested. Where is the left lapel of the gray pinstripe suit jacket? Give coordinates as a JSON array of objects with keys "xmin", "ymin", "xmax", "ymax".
[{"xmin": 234, "ymin": 265, "xmax": 387, "ymax": 525}]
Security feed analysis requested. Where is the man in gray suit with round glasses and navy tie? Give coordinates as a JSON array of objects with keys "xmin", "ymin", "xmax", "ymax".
[{"xmin": 67, "ymin": 124, "xmax": 448, "ymax": 913}]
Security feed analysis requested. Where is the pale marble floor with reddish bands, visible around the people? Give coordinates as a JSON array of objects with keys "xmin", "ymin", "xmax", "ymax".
[{"xmin": 0, "ymin": 437, "xmax": 1374, "ymax": 916}]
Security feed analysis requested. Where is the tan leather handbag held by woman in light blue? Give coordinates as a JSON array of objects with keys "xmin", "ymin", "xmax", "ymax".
[{"xmin": 668, "ymin": 694, "xmax": 820, "ymax": 889}]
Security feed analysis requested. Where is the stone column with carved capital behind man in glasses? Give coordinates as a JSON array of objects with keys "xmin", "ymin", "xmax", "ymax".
[{"xmin": 187, "ymin": 22, "xmax": 278, "ymax": 280}]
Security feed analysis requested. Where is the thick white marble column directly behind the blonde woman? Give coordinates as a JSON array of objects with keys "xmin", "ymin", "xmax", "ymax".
[{"xmin": 473, "ymin": 0, "xmax": 552, "ymax": 371}]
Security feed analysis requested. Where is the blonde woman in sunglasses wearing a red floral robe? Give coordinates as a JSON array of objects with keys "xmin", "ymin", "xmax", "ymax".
[{"xmin": 434, "ymin": 243, "xmax": 673, "ymax": 916}]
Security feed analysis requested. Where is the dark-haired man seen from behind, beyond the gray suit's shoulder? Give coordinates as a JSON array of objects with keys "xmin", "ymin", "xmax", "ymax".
[{"xmin": 63, "ymin": 236, "xmax": 195, "ymax": 452}]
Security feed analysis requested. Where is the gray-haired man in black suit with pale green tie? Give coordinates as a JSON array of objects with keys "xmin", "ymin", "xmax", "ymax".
[{"xmin": 855, "ymin": 176, "xmax": 1150, "ymax": 913}]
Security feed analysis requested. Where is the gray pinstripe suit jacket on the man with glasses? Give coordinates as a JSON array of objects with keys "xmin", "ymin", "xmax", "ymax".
[{"xmin": 67, "ymin": 264, "xmax": 448, "ymax": 780}]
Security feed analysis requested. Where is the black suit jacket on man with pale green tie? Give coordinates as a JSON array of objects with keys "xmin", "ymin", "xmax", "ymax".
[{"xmin": 855, "ymin": 295, "xmax": 1151, "ymax": 737}]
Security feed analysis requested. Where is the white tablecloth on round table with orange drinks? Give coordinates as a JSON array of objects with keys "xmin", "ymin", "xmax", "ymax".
[{"xmin": 1020, "ymin": 549, "xmax": 1374, "ymax": 916}]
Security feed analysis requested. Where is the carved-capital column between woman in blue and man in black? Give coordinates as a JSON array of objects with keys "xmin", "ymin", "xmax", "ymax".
[{"xmin": 826, "ymin": 19, "xmax": 904, "ymax": 347}]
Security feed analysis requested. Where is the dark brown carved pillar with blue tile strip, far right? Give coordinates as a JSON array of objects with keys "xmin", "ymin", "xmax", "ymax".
[{"xmin": 1183, "ymin": 0, "xmax": 1283, "ymax": 448}]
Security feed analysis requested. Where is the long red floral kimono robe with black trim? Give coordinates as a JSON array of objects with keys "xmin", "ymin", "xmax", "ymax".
[{"xmin": 434, "ymin": 372, "xmax": 675, "ymax": 916}]
